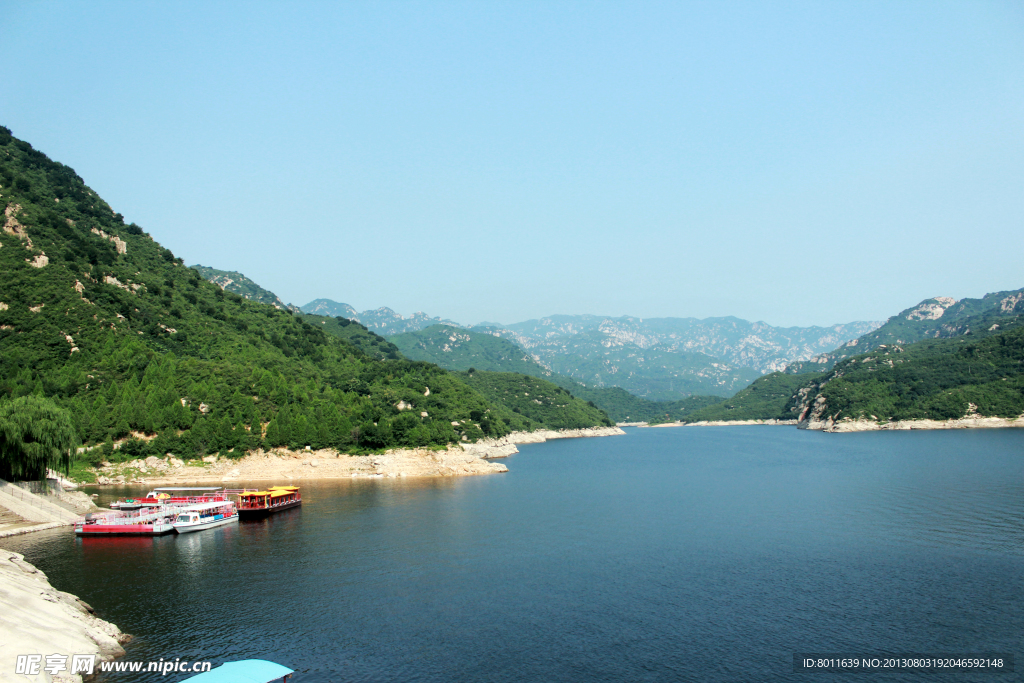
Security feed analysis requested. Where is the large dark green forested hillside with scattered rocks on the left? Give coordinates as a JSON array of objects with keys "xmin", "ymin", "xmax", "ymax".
[{"xmin": 0, "ymin": 129, "xmax": 569, "ymax": 466}]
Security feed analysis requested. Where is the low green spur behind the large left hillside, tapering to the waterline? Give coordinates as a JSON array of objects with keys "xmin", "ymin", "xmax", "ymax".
[{"xmin": 460, "ymin": 371, "xmax": 614, "ymax": 429}]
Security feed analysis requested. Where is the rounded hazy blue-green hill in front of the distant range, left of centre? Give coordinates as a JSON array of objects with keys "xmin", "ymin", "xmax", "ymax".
[{"xmin": 388, "ymin": 325, "xmax": 551, "ymax": 377}]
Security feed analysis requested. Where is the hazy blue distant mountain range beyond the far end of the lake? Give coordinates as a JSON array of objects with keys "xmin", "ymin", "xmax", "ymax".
[{"xmin": 197, "ymin": 268, "xmax": 881, "ymax": 401}]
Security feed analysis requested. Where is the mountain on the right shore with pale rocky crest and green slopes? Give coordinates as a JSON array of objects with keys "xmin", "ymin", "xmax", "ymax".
[{"xmin": 684, "ymin": 289, "xmax": 1024, "ymax": 430}]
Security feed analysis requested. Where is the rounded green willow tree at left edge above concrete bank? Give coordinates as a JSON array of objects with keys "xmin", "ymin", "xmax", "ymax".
[{"xmin": 0, "ymin": 396, "xmax": 78, "ymax": 479}]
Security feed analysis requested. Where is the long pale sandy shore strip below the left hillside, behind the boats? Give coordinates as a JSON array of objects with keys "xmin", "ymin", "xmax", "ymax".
[{"xmin": 86, "ymin": 427, "xmax": 626, "ymax": 485}]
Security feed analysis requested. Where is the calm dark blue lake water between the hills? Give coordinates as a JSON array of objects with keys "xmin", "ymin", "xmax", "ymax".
[{"xmin": 2, "ymin": 427, "xmax": 1024, "ymax": 683}]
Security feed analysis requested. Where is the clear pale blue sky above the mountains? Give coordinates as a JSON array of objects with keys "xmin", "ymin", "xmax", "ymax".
[{"xmin": 0, "ymin": 1, "xmax": 1024, "ymax": 325}]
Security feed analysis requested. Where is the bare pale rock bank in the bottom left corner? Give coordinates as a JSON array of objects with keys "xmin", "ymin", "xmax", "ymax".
[{"xmin": 0, "ymin": 550, "xmax": 131, "ymax": 683}]
